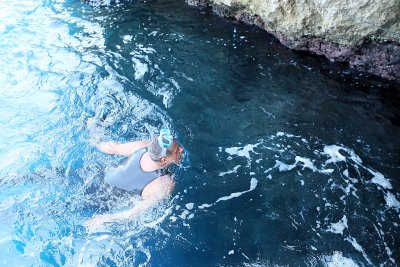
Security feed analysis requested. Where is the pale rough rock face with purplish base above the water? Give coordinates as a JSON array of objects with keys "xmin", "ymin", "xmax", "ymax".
[{"xmin": 187, "ymin": 0, "xmax": 400, "ymax": 81}]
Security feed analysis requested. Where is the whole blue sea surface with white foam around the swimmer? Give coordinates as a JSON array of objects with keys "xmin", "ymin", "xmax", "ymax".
[{"xmin": 0, "ymin": 0, "xmax": 400, "ymax": 266}]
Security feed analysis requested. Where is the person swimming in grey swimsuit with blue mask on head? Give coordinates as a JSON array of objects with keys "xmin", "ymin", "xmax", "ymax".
[{"xmin": 86, "ymin": 128, "xmax": 183, "ymax": 231}]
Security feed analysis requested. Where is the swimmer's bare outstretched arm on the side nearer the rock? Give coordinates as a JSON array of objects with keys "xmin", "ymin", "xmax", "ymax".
[{"xmin": 97, "ymin": 140, "xmax": 149, "ymax": 157}]
